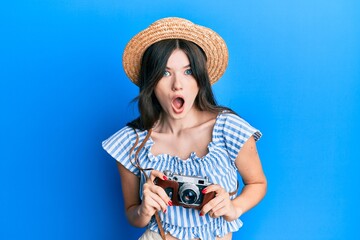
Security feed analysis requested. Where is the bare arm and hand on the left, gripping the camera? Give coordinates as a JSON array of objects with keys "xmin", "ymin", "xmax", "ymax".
[{"xmin": 117, "ymin": 163, "xmax": 170, "ymax": 227}]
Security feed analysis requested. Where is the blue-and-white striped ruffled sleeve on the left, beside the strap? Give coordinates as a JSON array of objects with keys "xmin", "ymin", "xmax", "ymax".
[{"xmin": 102, "ymin": 126, "xmax": 140, "ymax": 177}]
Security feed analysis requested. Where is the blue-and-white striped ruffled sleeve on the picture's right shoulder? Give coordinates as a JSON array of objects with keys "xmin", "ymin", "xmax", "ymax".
[{"xmin": 222, "ymin": 113, "xmax": 262, "ymax": 161}]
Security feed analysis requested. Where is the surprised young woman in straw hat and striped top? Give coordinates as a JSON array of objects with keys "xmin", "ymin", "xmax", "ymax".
[{"xmin": 103, "ymin": 18, "xmax": 267, "ymax": 239}]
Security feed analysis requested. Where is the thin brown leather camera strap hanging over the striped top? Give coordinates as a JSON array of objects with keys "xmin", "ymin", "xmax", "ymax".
[{"xmin": 130, "ymin": 129, "xmax": 239, "ymax": 240}]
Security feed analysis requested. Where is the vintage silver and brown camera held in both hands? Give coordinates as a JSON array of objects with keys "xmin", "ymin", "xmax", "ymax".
[{"xmin": 155, "ymin": 171, "xmax": 215, "ymax": 210}]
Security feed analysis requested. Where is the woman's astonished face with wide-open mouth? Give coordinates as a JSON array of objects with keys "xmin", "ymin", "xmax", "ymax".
[{"xmin": 155, "ymin": 49, "xmax": 199, "ymax": 119}]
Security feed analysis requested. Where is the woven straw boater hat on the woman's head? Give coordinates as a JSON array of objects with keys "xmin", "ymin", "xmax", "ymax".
[{"xmin": 123, "ymin": 17, "xmax": 228, "ymax": 85}]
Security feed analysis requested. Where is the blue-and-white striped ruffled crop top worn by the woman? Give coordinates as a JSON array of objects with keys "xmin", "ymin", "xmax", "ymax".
[{"xmin": 102, "ymin": 112, "xmax": 261, "ymax": 239}]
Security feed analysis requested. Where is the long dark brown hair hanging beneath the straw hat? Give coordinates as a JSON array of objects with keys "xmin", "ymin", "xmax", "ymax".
[{"xmin": 127, "ymin": 39, "xmax": 232, "ymax": 130}]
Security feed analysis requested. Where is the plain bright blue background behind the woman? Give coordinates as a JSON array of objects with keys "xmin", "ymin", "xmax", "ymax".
[{"xmin": 0, "ymin": 0, "xmax": 360, "ymax": 240}]
